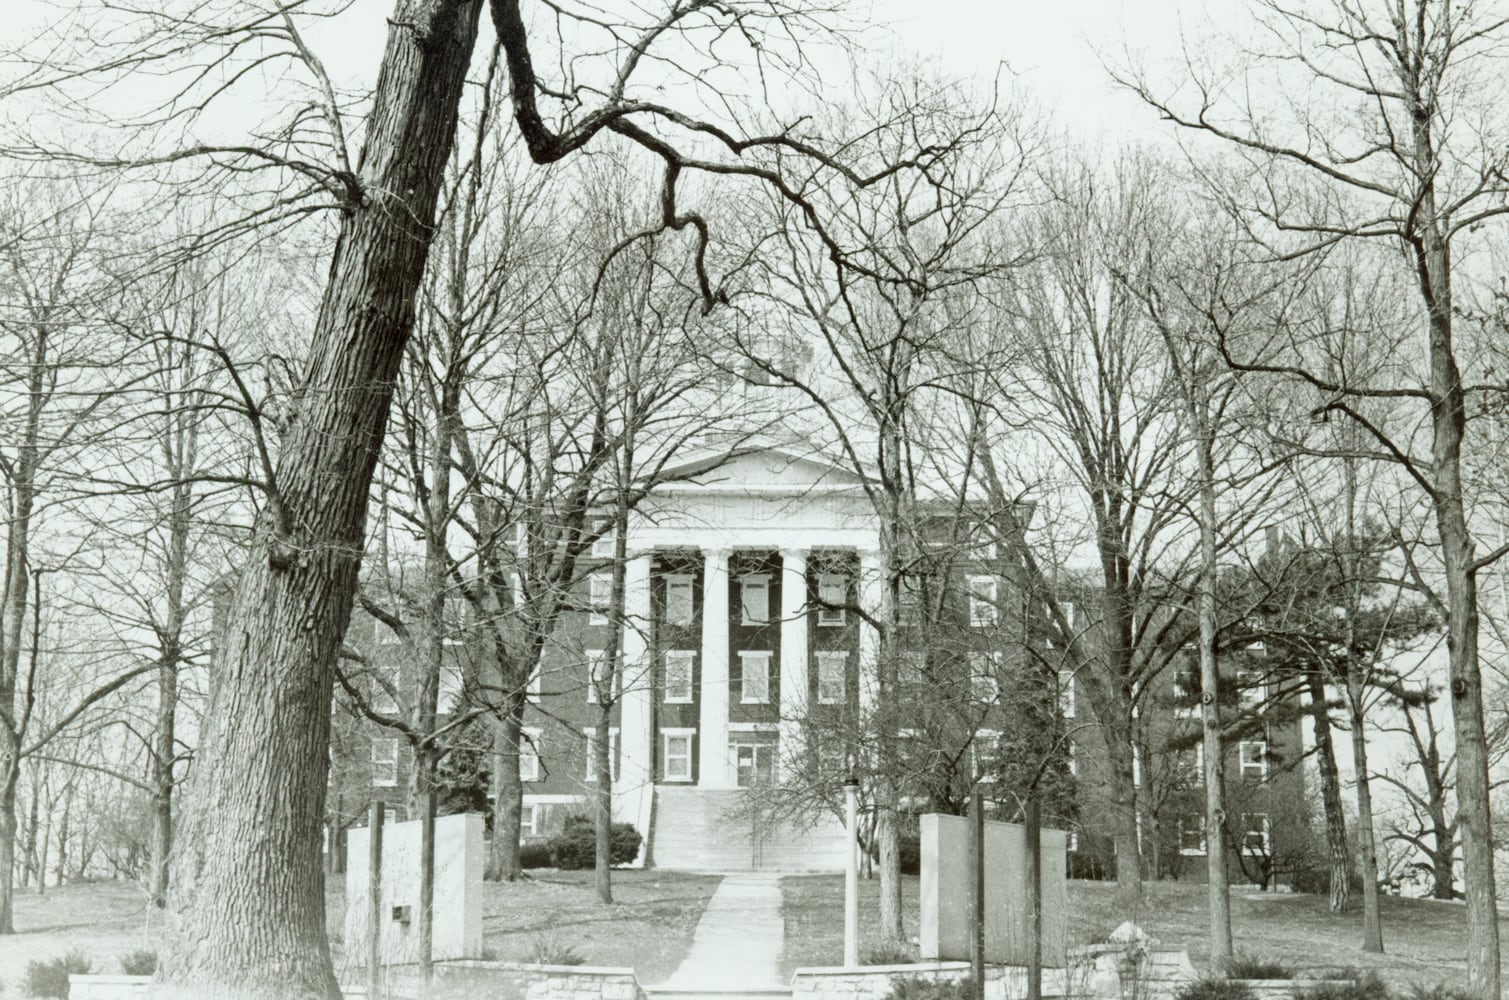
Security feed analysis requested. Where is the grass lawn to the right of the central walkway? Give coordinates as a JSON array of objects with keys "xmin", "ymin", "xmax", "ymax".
[{"xmin": 780, "ymin": 875, "xmax": 1509, "ymax": 986}]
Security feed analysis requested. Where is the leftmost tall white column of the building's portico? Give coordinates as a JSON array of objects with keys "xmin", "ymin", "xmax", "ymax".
[{"xmin": 613, "ymin": 552, "xmax": 655, "ymax": 837}]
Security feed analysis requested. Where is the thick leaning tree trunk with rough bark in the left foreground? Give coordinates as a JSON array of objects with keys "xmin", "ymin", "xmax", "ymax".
[{"xmin": 160, "ymin": 0, "xmax": 480, "ymax": 1000}]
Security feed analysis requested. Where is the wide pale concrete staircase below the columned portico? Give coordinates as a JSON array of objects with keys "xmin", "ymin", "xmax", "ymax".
[{"xmin": 649, "ymin": 784, "xmax": 845, "ymax": 872}]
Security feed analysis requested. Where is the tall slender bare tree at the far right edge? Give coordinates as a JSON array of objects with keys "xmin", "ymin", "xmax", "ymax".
[{"xmin": 1123, "ymin": 0, "xmax": 1506, "ymax": 1000}]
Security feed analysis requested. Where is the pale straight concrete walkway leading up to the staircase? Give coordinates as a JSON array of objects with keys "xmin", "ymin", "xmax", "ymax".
[{"xmin": 650, "ymin": 873, "xmax": 788, "ymax": 992}]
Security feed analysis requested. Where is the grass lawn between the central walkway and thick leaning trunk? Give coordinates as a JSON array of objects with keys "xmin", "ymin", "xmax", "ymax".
[{"xmin": 326, "ymin": 869, "xmax": 720, "ymax": 983}]
